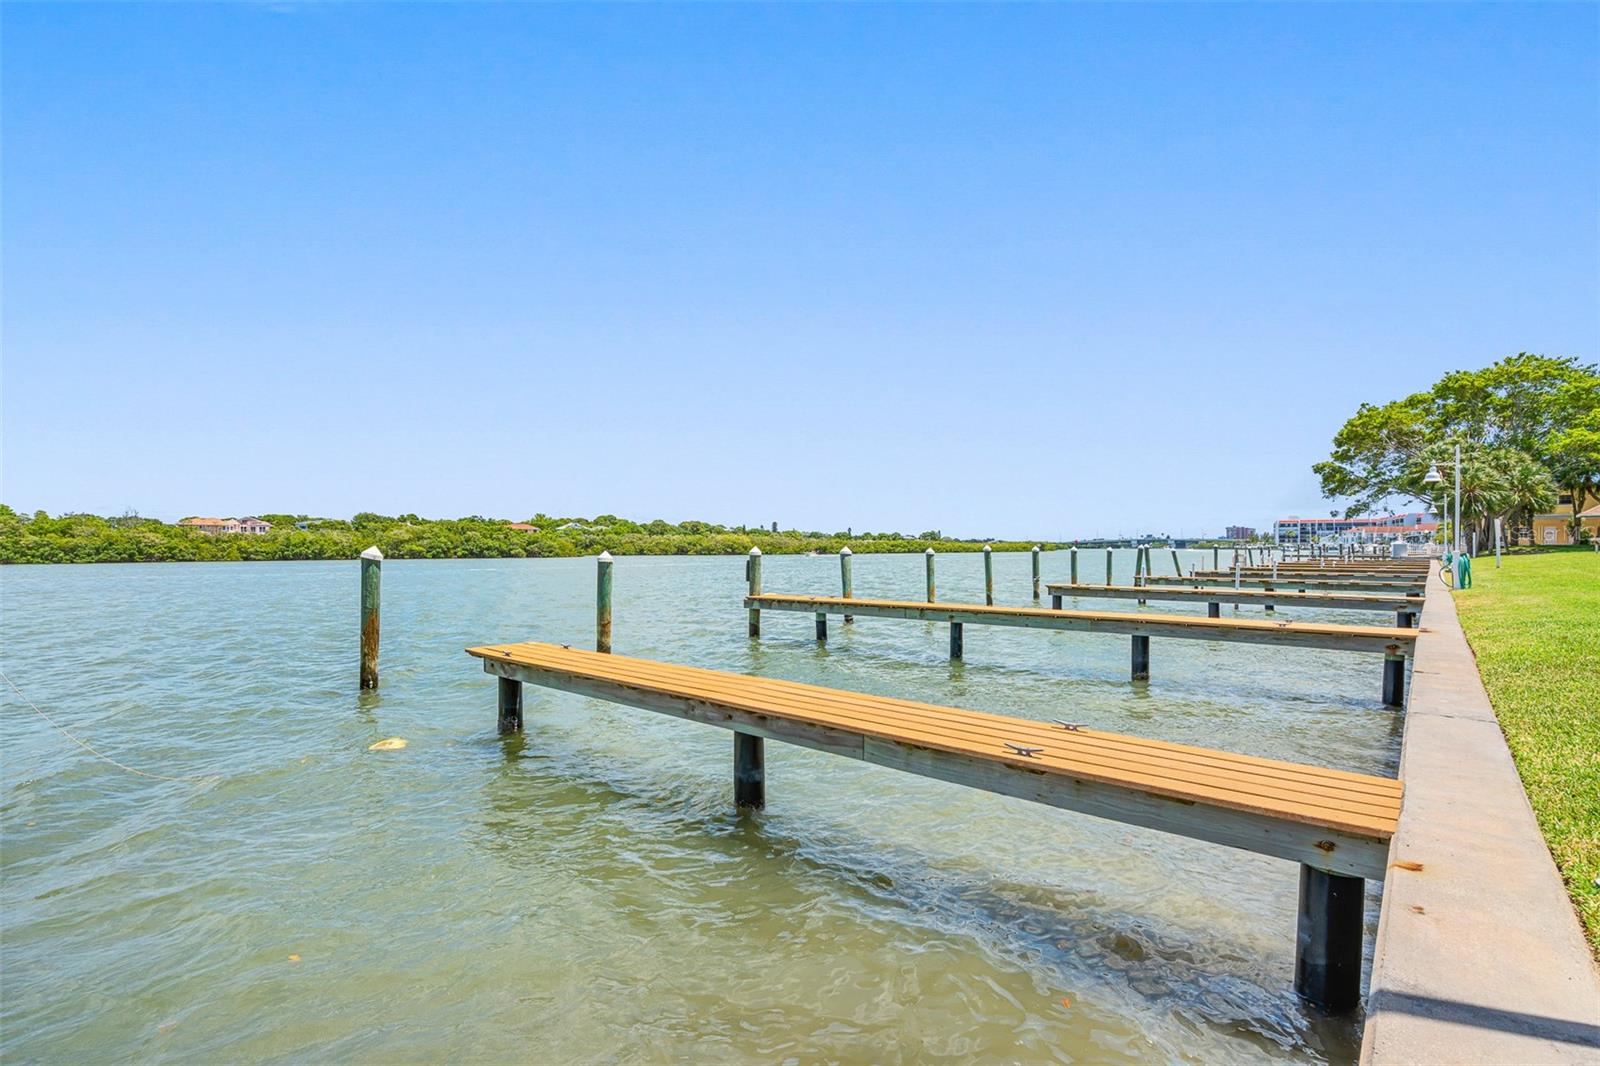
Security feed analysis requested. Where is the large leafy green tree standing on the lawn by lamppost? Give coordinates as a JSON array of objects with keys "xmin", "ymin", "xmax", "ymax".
[{"xmin": 1312, "ymin": 352, "xmax": 1600, "ymax": 543}]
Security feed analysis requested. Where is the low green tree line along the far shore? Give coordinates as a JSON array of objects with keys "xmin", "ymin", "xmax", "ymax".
[{"xmin": 0, "ymin": 504, "xmax": 1051, "ymax": 563}]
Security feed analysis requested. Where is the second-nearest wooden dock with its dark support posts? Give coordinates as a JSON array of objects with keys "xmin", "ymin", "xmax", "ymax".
[{"xmin": 744, "ymin": 592, "xmax": 1416, "ymax": 706}]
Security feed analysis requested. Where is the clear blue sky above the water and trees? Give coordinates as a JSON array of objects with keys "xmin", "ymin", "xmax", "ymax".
[{"xmin": 0, "ymin": 3, "xmax": 1600, "ymax": 536}]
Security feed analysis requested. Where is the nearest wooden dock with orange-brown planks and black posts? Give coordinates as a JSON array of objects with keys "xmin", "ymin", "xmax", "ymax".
[{"xmin": 467, "ymin": 633, "xmax": 1403, "ymax": 1010}]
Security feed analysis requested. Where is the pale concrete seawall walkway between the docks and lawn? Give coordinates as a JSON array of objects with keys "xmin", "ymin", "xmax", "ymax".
[{"xmin": 1362, "ymin": 571, "xmax": 1600, "ymax": 1066}]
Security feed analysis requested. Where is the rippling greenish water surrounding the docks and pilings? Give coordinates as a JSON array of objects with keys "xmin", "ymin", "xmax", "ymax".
[{"xmin": 0, "ymin": 552, "xmax": 1400, "ymax": 1063}]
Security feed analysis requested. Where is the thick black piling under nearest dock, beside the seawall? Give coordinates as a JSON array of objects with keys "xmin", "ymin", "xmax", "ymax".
[{"xmin": 1294, "ymin": 864, "xmax": 1366, "ymax": 1015}]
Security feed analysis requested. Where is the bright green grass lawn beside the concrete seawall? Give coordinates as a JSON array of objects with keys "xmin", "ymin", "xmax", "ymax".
[{"xmin": 1456, "ymin": 549, "xmax": 1600, "ymax": 956}]
